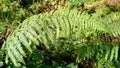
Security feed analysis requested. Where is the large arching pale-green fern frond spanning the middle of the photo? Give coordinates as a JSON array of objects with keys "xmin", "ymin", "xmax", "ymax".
[{"xmin": 2, "ymin": 8, "xmax": 120, "ymax": 67}]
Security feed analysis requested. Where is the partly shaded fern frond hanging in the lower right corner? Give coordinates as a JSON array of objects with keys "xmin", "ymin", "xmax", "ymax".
[{"xmin": 76, "ymin": 39, "xmax": 119, "ymax": 68}]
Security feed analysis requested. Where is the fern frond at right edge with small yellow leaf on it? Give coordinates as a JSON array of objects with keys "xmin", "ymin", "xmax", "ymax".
[{"xmin": 103, "ymin": 12, "xmax": 120, "ymax": 37}]
